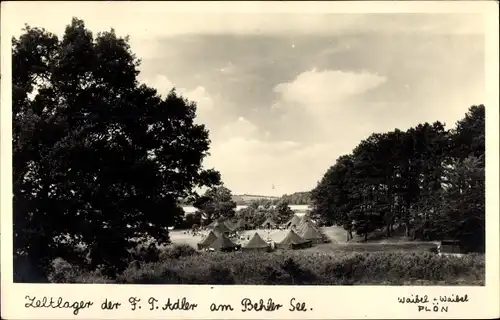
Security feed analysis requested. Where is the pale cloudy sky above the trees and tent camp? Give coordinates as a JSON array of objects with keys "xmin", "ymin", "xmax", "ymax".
[{"xmin": 3, "ymin": 2, "xmax": 485, "ymax": 196}]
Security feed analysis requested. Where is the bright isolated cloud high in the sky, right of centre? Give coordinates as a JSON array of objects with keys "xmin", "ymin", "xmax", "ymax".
[{"xmin": 270, "ymin": 69, "xmax": 387, "ymax": 139}]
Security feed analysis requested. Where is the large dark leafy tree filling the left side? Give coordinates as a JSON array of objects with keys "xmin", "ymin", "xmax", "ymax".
[{"xmin": 12, "ymin": 18, "xmax": 220, "ymax": 282}]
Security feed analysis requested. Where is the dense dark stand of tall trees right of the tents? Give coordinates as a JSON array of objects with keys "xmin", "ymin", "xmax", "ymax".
[{"xmin": 311, "ymin": 105, "xmax": 485, "ymax": 251}]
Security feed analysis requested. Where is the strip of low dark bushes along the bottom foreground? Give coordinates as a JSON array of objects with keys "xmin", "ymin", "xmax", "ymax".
[{"xmin": 49, "ymin": 245, "xmax": 485, "ymax": 285}]
